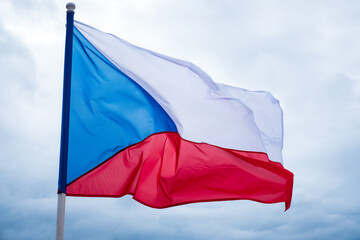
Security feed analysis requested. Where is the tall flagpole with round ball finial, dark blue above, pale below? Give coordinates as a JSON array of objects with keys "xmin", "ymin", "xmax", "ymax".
[{"xmin": 56, "ymin": 2, "xmax": 76, "ymax": 240}]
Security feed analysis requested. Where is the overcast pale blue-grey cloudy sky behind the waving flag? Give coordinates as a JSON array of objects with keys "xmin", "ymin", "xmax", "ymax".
[{"xmin": 0, "ymin": 0, "xmax": 360, "ymax": 240}]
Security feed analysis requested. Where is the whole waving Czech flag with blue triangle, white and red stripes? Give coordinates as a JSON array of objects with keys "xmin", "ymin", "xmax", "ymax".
[{"xmin": 59, "ymin": 22, "xmax": 293, "ymax": 209}]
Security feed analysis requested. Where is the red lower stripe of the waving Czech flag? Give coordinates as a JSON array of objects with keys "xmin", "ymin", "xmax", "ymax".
[{"xmin": 67, "ymin": 132, "xmax": 293, "ymax": 210}]
